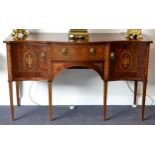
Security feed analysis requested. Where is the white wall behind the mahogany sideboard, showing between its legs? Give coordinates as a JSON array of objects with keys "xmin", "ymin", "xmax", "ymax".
[{"xmin": 0, "ymin": 29, "xmax": 155, "ymax": 105}]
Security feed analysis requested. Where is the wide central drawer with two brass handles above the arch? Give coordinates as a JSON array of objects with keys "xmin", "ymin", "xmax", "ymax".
[{"xmin": 51, "ymin": 44, "xmax": 106, "ymax": 61}]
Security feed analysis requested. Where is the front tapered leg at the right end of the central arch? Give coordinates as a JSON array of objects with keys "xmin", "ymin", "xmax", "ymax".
[{"xmin": 103, "ymin": 81, "xmax": 108, "ymax": 120}]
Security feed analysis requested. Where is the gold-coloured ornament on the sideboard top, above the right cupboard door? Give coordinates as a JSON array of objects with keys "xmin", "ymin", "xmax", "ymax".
[{"xmin": 126, "ymin": 29, "xmax": 143, "ymax": 40}]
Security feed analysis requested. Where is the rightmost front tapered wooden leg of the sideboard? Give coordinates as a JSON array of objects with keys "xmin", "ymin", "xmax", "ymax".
[{"xmin": 142, "ymin": 81, "xmax": 147, "ymax": 121}]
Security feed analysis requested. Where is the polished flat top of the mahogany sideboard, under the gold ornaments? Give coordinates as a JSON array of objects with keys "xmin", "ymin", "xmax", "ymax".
[{"xmin": 3, "ymin": 33, "xmax": 152, "ymax": 44}]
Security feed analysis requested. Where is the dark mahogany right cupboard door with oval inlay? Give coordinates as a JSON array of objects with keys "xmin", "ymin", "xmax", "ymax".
[{"xmin": 110, "ymin": 43, "xmax": 146, "ymax": 80}]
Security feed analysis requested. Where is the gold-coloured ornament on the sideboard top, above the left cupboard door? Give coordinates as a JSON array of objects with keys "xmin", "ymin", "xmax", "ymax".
[{"xmin": 12, "ymin": 29, "xmax": 29, "ymax": 40}]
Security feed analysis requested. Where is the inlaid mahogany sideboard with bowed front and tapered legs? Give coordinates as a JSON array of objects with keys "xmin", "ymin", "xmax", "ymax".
[{"xmin": 4, "ymin": 33, "xmax": 153, "ymax": 120}]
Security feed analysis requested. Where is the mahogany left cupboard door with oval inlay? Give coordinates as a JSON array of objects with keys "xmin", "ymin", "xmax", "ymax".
[{"xmin": 11, "ymin": 43, "xmax": 50, "ymax": 79}]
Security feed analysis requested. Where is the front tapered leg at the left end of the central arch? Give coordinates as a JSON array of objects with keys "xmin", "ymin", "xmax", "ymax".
[{"xmin": 48, "ymin": 81, "xmax": 52, "ymax": 121}]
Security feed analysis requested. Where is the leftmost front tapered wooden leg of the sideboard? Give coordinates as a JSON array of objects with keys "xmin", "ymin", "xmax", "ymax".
[{"xmin": 9, "ymin": 81, "xmax": 14, "ymax": 120}]
